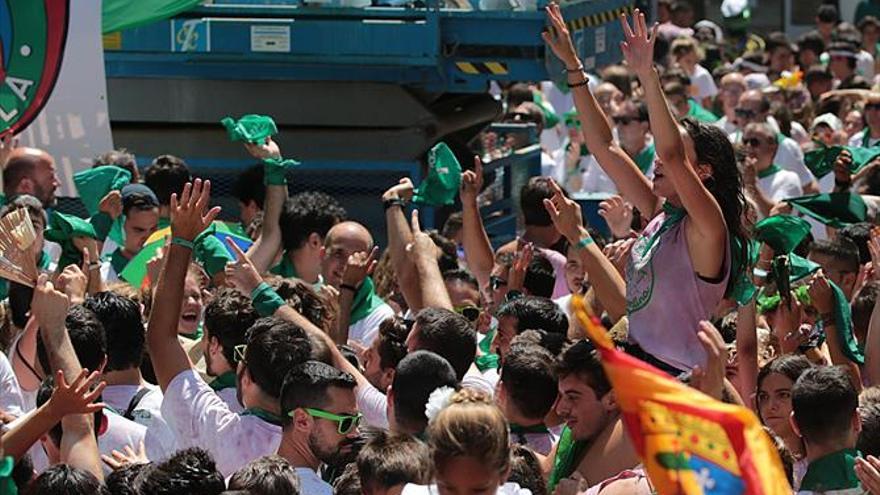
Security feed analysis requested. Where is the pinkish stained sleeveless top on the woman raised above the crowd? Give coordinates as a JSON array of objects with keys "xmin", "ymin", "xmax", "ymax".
[{"xmin": 626, "ymin": 207, "xmax": 730, "ymax": 371}]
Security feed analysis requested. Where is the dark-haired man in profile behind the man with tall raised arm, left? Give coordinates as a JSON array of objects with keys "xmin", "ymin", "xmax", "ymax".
[{"xmin": 200, "ymin": 289, "xmax": 259, "ymax": 413}]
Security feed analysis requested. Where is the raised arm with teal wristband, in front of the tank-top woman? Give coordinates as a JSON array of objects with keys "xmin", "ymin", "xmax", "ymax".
[{"xmin": 544, "ymin": 182, "xmax": 626, "ymax": 321}]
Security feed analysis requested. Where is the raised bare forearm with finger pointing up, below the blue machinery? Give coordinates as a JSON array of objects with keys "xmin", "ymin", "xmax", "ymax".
[{"xmin": 459, "ymin": 156, "xmax": 495, "ymax": 290}]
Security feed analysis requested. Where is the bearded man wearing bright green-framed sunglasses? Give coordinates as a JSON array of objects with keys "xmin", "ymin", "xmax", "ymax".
[{"xmin": 278, "ymin": 361, "xmax": 361, "ymax": 495}]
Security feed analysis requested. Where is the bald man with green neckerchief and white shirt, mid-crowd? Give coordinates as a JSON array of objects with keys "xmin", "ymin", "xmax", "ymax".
[{"xmin": 321, "ymin": 221, "xmax": 394, "ymax": 347}]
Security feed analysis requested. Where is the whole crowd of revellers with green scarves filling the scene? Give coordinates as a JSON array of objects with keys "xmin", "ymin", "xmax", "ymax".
[{"xmin": 6, "ymin": 1, "xmax": 880, "ymax": 495}]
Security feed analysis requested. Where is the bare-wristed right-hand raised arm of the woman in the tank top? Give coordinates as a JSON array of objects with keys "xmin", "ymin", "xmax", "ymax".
[{"xmin": 620, "ymin": 9, "xmax": 727, "ymax": 278}]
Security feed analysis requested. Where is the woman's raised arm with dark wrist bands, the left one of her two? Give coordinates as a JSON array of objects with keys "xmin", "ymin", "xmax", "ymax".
[{"xmin": 543, "ymin": 4, "xmax": 659, "ymax": 218}]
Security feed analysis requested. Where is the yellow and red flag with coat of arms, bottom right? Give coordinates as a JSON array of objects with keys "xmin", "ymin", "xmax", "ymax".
[{"xmin": 573, "ymin": 297, "xmax": 792, "ymax": 495}]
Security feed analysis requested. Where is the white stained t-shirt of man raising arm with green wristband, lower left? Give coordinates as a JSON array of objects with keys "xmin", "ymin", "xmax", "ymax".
[{"xmin": 162, "ymin": 369, "xmax": 281, "ymax": 477}]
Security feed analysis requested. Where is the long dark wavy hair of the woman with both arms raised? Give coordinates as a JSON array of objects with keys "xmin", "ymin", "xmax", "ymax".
[{"xmin": 681, "ymin": 118, "xmax": 750, "ymax": 293}]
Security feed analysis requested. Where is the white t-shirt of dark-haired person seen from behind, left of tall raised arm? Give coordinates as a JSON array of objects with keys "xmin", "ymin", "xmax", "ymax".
[{"xmin": 101, "ymin": 384, "xmax": 177, "ymax": 461}]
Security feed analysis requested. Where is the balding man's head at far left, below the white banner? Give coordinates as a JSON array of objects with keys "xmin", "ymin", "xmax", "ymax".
[{"xmin": 3, "ymin": 147, "xmax": 59, "ymax": 208}]
